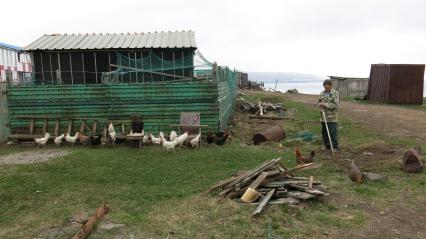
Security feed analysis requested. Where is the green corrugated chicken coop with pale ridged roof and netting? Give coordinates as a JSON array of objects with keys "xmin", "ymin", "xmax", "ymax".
[{"xmin": 0, "ymin": 31, "xmax": 239, "ymax": 138}]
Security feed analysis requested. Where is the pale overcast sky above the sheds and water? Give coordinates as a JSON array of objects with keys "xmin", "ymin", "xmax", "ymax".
[{"xmin": 0, "ymin": 0, "xmax": 426, "ymax": 77}]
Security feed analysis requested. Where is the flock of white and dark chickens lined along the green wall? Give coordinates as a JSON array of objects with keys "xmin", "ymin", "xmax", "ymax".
[{"xmin": 34, "ymin": 123, "xmax": 229, "ymax": 153}]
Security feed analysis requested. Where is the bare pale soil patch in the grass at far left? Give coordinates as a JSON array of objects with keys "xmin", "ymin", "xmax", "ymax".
[{"xmin": 0, "ymin": 150, "xmax": 69, "ymax": 165}]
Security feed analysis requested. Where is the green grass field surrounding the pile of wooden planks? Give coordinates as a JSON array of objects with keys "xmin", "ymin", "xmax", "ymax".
[{"xmin": 0, "ymin": 93, "xmax": 426, "ymax": 238}]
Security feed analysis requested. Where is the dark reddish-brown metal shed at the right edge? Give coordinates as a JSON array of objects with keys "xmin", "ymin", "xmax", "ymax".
[{"xmin": 367, "ymin": 64, "xmax": 425, "ymax": 104}]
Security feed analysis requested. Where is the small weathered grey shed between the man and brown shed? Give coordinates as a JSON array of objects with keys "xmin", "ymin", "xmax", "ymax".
[{"xmin": 329, "ymin": 76, "xmax": 368, "ymax": 97}]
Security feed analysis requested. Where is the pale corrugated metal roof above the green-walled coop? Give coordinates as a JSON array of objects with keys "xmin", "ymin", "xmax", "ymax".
[{"xmin": 24, "ymin": 31, "xmax": 197, "ymax": 51}]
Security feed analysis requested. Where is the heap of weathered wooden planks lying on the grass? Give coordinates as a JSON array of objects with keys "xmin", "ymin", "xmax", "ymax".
[{"xmin": 207, "ymin": 158, "xmax": 329, "ymax": 216}]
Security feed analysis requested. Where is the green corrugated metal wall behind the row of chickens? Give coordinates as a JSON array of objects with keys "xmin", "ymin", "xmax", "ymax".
[{"xmin": 8, "ymin": 81, "xmax": 223, "ymax": 134}]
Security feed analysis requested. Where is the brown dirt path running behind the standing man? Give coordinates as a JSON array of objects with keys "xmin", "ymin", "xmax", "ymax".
[{"xmin": 288, "ymin": 95, "xmax": 426, "ymax": 143}]
